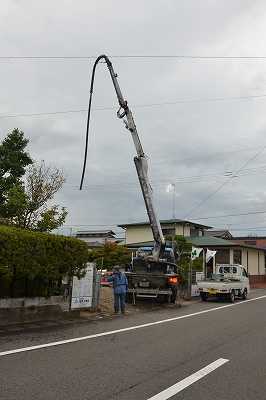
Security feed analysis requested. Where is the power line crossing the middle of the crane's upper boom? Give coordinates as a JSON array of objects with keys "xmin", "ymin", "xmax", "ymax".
[{"xmin": 0, "ymin": 94, "xmax": 266, "ymax": 118}]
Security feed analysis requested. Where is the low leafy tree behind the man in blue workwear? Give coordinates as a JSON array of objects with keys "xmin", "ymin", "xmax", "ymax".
[{"xmin": 89, "ymin": 241, "xmax": 132, "ymax": 270}]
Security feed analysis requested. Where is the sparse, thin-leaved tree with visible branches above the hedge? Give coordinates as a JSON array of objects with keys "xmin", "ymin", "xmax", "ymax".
[{"xmin": 2, "ymin": 160, "xmax": 67, "ymax": 232}]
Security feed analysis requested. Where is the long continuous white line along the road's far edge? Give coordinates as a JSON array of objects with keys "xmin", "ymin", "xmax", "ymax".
[{"xmin": 0, "ymin": 295, "xmax": 266, "ymax": 357}]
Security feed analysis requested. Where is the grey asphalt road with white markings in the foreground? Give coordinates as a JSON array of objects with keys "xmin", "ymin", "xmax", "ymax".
[{"xmin": 0, "ymin": 289, "xmax": 266, "ymax": 400}]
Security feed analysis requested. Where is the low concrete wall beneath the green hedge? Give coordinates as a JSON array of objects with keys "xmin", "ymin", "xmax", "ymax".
[{"xmin": 0, "ymin": 296, "xmax": 80, "ymax": 326}]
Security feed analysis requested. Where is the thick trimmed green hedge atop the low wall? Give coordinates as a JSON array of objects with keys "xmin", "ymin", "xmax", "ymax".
[{"xmin": 0, "ymin": 226, "xmax": 88, "ymax": 298}]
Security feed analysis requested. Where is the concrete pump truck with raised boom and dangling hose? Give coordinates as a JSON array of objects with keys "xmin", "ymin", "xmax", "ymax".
[{"xmin": 80, "ymin": 54, "xmax": 178, "ymax": 304}]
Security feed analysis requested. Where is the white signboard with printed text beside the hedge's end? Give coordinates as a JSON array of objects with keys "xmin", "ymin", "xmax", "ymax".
[{"xmin": 70, "ymin": 263, "xmax": 94, "ymax": 309}]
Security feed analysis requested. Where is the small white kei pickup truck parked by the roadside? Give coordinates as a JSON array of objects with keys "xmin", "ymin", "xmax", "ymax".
[{"xmin": 197, "ymin": 264, "xmax": 250, "ymax": 303}]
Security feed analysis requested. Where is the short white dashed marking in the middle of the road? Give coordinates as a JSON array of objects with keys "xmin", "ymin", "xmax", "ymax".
[{"xmin": 148, "ymin": 358, "xmax": 229, "ymax": 400}]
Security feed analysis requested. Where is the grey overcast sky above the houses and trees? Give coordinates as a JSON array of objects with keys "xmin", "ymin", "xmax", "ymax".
[{"xmin": 0, "ymin": 0, "xmax": 266, "ymax": 237}]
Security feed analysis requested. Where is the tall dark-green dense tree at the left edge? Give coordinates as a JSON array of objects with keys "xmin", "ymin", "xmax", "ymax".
[{"xmin": 0, "ymin": 128, "xmax": 33, "ymax": 205}]
